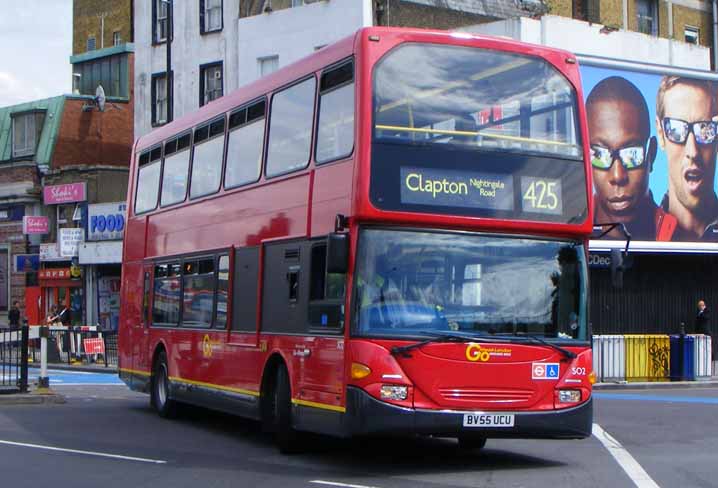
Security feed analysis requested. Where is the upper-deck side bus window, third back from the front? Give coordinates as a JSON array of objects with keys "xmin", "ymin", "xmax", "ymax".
[{"xmin": 224, "ymin": 100, "xmax": 267, "ymax": 188}]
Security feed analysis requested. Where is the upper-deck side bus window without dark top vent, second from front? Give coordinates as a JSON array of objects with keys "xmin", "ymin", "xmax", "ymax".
[{"xmin": 267, "ymin": 77, "xmax": 317, "ymax": 176}]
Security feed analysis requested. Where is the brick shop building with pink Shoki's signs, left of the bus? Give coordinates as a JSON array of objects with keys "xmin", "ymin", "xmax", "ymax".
[{"xmin": 0, "ymin": 0, "xmax": 134, "ymax": 326}]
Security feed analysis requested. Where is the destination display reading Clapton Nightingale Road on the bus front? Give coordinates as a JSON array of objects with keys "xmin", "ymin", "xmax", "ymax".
[{"xmin": 401, "ymin": 166, "xmax": 514, "ymax": 211}]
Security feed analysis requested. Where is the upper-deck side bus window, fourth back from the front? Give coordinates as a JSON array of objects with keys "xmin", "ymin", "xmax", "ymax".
[{"xmin": 190, "ymin": 117, "xmax": 224, "ymax": 198}]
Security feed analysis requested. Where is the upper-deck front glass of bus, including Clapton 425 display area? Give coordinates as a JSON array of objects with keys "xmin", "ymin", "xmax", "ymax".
[{"xmin": 371, "ymin": 43, "xmax": 587, "ymax": 223}]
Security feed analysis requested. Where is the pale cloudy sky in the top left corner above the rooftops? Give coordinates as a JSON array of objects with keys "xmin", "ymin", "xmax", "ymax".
[{"xmin": 0, "ymin": 0, "xmax": 72, "ymax": 107}]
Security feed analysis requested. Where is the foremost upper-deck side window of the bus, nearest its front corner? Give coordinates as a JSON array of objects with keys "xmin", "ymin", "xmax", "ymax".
[{"xmin": 316, "ymin": 62, "xmax": 354, "ymax": 163}]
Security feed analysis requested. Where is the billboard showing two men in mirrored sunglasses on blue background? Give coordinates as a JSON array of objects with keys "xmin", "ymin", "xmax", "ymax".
[{"xmin": 581, "ymin": 60, "xmax": 718, "ymax": 252}]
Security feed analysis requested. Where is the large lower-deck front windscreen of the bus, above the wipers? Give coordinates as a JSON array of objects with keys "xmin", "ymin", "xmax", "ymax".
[{"xmin": 353, "ymin": 229, "xmax": 587, "ymax": 341}]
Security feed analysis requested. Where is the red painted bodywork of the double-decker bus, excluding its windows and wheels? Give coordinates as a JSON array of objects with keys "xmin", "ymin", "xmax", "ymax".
[{"xmin": 119, "ymin": 28, "xmax": 593, "ymax": 446}]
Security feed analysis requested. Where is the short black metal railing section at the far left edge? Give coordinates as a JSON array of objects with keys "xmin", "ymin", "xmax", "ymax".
[{"xmin": 0, "ymin": 325, "xmax": 29, "ymax": 393}]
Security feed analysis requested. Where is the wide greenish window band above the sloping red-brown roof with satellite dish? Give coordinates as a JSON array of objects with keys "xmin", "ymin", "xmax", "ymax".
[{"xmin": 72, "ymin": 54, "xmax": 130, "ymax": 98}]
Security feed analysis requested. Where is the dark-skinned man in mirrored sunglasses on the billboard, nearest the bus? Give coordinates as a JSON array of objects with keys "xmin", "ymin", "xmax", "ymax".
[{"xmin": 586, "ymin": 76, "xmax": 677, "ymax": 241}]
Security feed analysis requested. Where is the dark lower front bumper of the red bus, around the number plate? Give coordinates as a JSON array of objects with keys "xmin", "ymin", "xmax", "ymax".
[{"xmin": 344, "ymin": 387, "xmax": 593, "ymax": 439}]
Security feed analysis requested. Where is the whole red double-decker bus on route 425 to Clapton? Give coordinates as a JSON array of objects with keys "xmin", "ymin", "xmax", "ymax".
[{"xmin": 119, "ymin": 28, "xmax": 593, "ymax": 451}]
